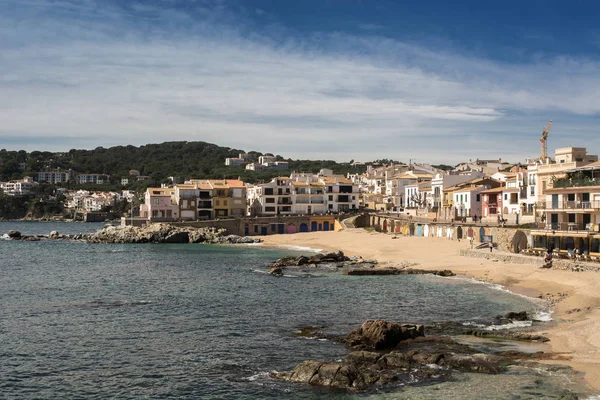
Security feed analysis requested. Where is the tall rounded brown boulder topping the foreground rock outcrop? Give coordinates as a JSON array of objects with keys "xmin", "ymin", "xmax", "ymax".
[{"xmin": 342, "ymin": 319, "xmax": 425, "ymax": 350}]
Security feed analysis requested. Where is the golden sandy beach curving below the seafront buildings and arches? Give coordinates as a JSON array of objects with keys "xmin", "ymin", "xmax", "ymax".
[{"xmin": 263, "ymin": 229, "xmax": 600, "ymax": 391}]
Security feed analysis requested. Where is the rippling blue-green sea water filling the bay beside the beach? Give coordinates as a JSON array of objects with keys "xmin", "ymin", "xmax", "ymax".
[{"xmin": 0, "ymin": 222, "xmax": 589, "ymax": 399}]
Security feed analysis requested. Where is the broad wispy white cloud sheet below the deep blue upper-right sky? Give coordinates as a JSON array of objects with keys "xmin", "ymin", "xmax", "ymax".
[{"xmin": 0, "ymin": 0, "xmax": 600, "ymax": 162}]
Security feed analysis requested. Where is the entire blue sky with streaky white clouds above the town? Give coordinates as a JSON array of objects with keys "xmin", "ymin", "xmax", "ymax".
[{"xmin": 0, "ymin": 0, "xmax": 600, "ymax": 164}]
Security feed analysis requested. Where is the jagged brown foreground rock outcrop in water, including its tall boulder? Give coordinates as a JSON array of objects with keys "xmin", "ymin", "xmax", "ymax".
[{"xmin": 274, "ymin": 320, "xmax": 551, "ymax": 390}]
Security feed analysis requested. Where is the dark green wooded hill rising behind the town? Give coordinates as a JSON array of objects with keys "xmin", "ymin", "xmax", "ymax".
[{"xmin": 0, "ymin": 142, "xmax": 364, "ymax": 184}]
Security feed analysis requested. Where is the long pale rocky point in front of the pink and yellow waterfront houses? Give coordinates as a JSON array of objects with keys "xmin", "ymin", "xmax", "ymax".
[{"xmin": 4, "ymin": 224, "xmax": 261, "ymax": 244}]
